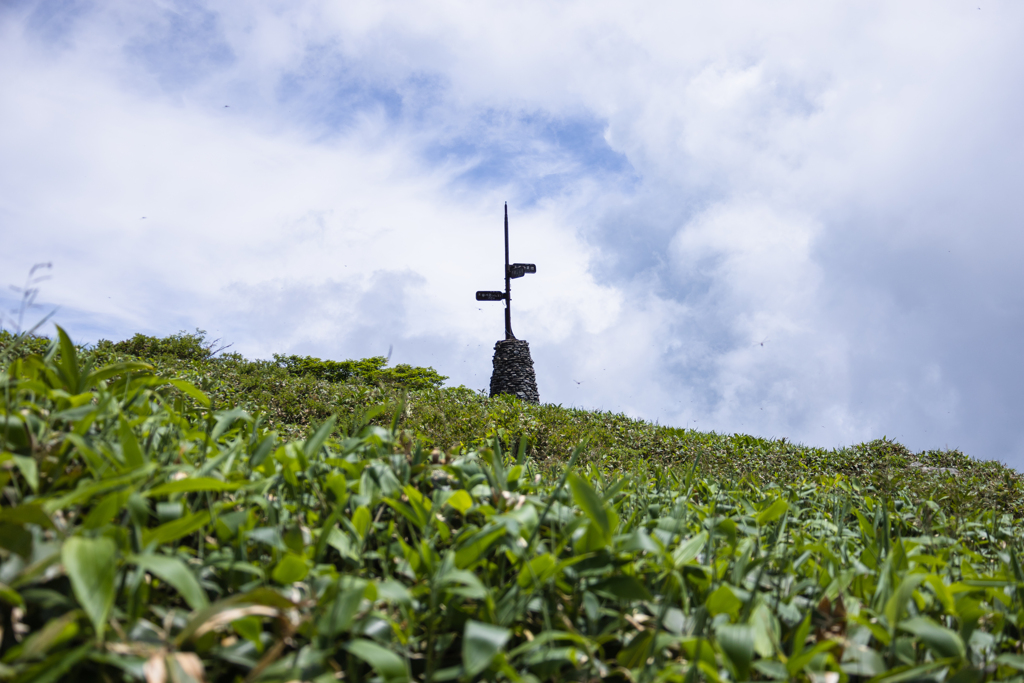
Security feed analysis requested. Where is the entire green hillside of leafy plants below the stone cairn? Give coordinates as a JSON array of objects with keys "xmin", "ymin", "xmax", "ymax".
[{"xmin": 0, "ymin": 331, "xmax": 1024, "ymax": 683}]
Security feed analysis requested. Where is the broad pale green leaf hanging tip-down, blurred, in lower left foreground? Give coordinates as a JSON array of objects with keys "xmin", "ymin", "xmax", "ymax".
[{"xmin": 60, "ymin": 536, "xmax": 118, "ymax": 638}]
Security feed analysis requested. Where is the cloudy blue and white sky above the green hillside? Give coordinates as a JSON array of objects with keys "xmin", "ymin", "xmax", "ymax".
[{"xmin": 6, "ymin": 0, "xmax": 1024, "ymax": 470}]
